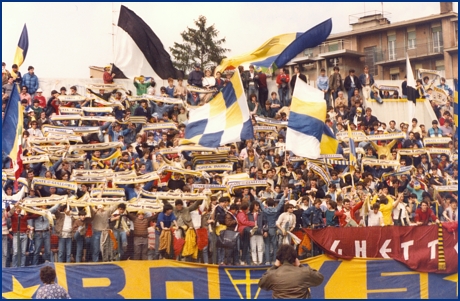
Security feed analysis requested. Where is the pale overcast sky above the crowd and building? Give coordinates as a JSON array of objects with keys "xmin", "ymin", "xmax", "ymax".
[{"xmin": 2, "ymin": 2, "xmax": 458, "ymax": 78}]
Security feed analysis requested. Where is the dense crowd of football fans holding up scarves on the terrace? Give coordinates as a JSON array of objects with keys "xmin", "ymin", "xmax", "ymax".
[{"xmin": 2, "ymin": 63, "xmax": 458, "ymax": 268}]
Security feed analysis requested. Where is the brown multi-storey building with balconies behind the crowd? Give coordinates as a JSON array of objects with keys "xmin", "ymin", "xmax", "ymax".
[{"xmin": 286, "ymin": 2, "xmax": 458, "ymax": 81}]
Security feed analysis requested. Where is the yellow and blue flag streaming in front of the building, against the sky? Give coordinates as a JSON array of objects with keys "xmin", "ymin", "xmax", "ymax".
[{"xmin": 216, "ymin": 19, "xmax": 332, "ymax": 72}]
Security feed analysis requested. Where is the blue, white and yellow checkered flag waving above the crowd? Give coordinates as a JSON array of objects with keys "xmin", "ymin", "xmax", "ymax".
[{"xmin": 181, "ymin": 70, "xmax": 254, "ymax": 147}]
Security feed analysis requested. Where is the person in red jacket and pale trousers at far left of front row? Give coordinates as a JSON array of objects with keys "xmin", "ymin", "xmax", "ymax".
[{"xmin": 6, "ymin": 203, "xmax": 40, "ymax": 268}]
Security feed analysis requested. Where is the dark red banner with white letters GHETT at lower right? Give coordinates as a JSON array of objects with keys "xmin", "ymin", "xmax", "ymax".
[{"xmin": 305, "ymin": 222, "xmax": 458, "ymax": 273}]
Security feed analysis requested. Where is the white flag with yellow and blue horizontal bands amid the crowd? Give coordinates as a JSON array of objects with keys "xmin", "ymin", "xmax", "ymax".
[{"xmin": 286, "ymin": 77, "xmax": 338, "ymax": 159}]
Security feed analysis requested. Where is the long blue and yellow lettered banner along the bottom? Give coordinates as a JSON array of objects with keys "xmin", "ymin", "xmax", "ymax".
[{"xmin": 2, "ymin": 255, "xmax": 458, "ymax": 299}]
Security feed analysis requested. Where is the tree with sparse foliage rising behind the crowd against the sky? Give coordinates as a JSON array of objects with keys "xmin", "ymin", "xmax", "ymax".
[{"xmin": 169, "ymin": 16, "xmax": 230, "ymax": 74}]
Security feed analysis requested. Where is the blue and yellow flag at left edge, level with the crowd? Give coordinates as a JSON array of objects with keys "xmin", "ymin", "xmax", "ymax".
[{"xmin": 2, "ymin": 87, "xmax": 24, "ymax": 179}]
